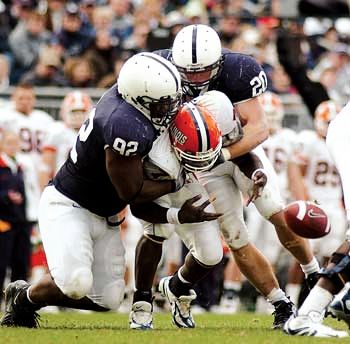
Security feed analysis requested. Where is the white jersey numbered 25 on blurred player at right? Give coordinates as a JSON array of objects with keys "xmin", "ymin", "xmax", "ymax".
[{"xmin": 297, "ymin": 130, "xmax": 342, "ymax": 205}]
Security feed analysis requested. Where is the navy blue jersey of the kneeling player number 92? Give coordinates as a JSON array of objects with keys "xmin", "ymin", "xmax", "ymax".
[{"xmin": 53, "ymin": 85, "xmax": 156, "ymax": 217}]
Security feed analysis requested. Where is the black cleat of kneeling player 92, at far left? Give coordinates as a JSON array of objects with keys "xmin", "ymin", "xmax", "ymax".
[{"xmin": 0, "ymin": 280, "xmax": 40, "ymax": 328}]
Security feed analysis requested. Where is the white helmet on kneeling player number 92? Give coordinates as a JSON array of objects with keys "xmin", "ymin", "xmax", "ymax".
[{"xmin": 118, "ymin": 53, "xmax": 182, "ymax": 130}]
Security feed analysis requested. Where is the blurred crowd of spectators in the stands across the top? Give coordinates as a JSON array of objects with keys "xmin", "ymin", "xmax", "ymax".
[{"xmin": 0, "ymin": 0, "xmax": 344, "ymax": 104}]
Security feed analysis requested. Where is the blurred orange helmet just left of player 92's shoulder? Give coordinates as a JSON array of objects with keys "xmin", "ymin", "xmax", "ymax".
[{"xmin": 60, "ymin": 91, "xmax": 92, "ymax": 129}]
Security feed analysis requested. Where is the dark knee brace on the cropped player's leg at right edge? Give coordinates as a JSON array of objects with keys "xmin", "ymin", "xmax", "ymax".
[{"xmin": 319, "ymin": 252, "xmax": 350, "ymax": 291}]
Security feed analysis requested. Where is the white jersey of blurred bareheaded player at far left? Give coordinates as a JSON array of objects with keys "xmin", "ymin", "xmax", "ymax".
[{"xmin": 1, "ymin": 109, "xmax": 54, "ymax": 166}]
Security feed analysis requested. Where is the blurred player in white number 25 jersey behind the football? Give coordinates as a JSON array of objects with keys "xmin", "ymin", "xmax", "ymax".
[{"xmin": 290, "ymin": 100, "xmax": 346, "ymax": 303}]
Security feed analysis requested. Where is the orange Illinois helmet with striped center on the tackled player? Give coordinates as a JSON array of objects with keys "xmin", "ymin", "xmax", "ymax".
[{"xmin": 169, "ymin": 102, "xmax": 222, "ymax": 172}]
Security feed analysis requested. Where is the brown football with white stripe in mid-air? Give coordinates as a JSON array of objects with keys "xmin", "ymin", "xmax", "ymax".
[{"xmin": 284, "ymin": 201, "xmax": 331, "ymax": 239}]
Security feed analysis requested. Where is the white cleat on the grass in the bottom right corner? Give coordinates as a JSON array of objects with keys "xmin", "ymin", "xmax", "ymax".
[{"xmin": 283, "ymin": 315, "xmax": 349, "ymax": 338}]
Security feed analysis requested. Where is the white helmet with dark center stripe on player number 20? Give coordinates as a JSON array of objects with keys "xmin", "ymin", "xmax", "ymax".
[{"xmin": 172, "ymin": 24, "xmax": 223, "ymax": 91}]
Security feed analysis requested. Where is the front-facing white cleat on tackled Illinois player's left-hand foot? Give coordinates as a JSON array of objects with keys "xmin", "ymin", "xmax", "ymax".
[{"xmin": 129, "ymin": 301, "xmax": 153, "ymax": 330}]
